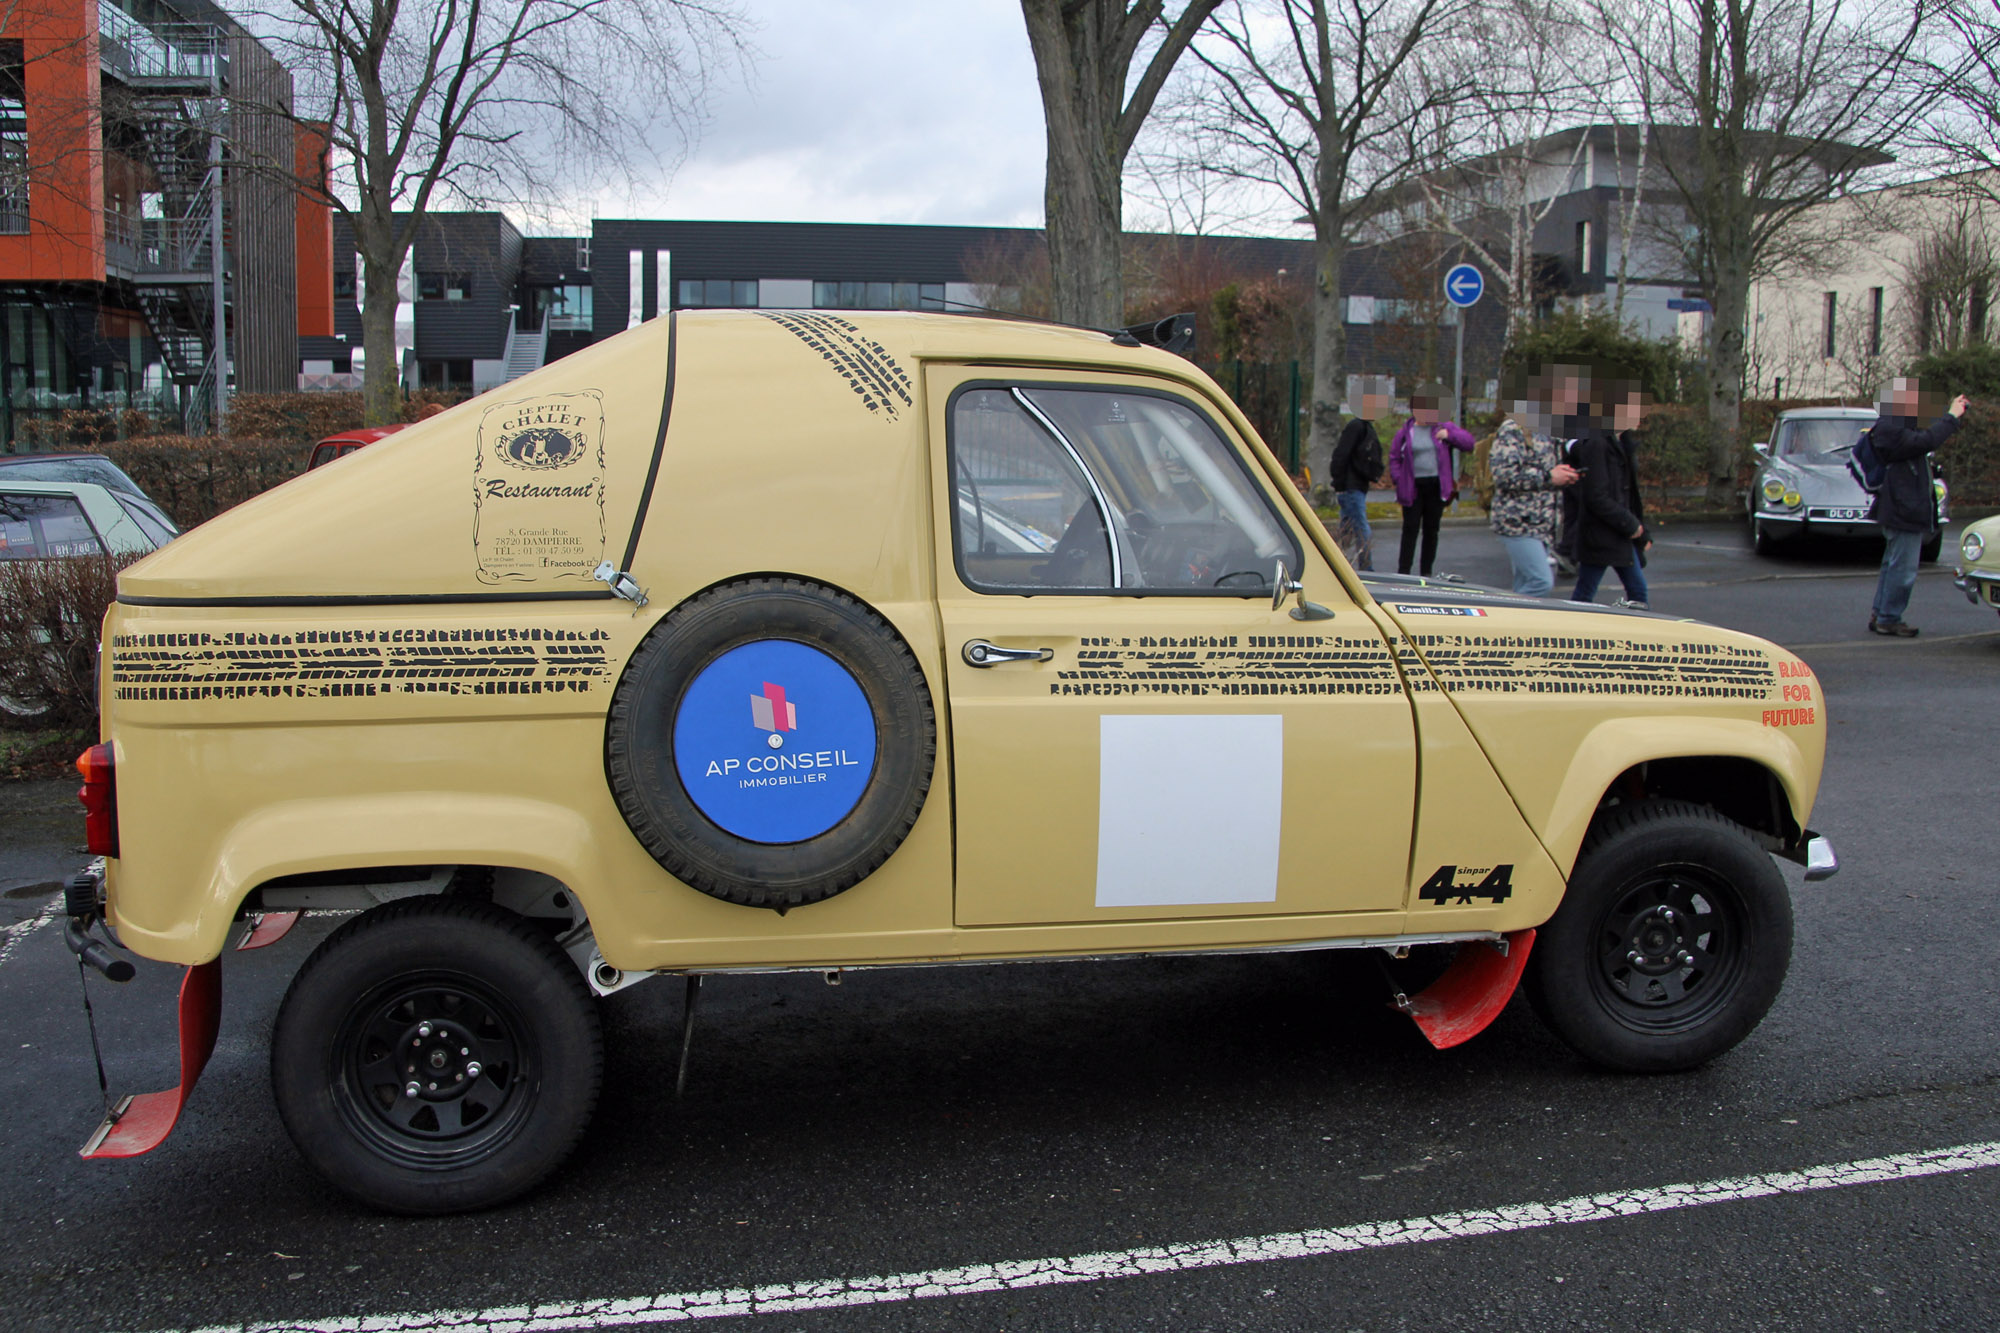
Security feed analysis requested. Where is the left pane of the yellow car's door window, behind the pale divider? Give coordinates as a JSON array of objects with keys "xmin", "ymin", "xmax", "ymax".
[{"xmin": 950, "ymin": 388, "xmax": 1114, "ymax": 592}]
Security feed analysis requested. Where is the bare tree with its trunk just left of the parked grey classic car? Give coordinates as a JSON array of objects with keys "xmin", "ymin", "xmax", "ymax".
[{"xmin": 1620, "ymin": 0, "xmax": 1936, "ymax": 506}]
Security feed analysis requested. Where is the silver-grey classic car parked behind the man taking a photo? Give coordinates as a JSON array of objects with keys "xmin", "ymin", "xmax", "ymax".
[{"xmin": 1744, "ymin": 408, "xmax": 1950, "ymax": 562}]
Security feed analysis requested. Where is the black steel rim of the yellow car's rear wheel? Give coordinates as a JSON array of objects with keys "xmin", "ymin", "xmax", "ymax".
[{"xmin": 330, "ymin": 971, "xmax": 538, "ymax": 1171}]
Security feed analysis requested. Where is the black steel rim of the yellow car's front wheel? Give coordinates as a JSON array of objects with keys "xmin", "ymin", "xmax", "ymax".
[{"xmin": 1590, "ymin": 865, "xmax": 1750, "ymax": 1035}]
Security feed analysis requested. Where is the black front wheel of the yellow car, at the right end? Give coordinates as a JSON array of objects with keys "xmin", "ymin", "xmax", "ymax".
[{"xmin": 1526, "ymin": 801, "xmax": 1792, "ymax": 1073}]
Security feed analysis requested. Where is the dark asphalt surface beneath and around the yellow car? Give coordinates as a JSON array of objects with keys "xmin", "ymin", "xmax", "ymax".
[{"xmin": 0, "ymin": 526, "xmax": 2000, "ymax": 1333}]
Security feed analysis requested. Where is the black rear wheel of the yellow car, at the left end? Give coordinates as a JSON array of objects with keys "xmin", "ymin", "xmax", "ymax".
[{"xmin": 270, "ymin": 899, "xmax": 604, "ymax": 1213}]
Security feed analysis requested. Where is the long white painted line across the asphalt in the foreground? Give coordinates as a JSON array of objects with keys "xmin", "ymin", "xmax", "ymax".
[{"xmin": 160, "ymin": 1143, "xmax": 2000, "ymax": 1333}]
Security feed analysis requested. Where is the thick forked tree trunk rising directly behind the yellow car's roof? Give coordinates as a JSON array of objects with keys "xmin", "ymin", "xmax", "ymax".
[{"xmin": 1020, "ymin": 0, "xmax": 1222, "ymax": 328}]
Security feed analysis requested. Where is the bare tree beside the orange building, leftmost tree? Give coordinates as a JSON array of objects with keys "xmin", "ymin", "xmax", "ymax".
[{"xmin": 248, "ymin": 0, "xmax": 740, "ymax": 424}]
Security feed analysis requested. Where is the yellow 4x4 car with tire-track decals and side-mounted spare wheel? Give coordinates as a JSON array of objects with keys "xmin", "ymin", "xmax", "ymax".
[{"xmin": 68, "ymin": 310, "xmax": 1834, "ymax": 1213}]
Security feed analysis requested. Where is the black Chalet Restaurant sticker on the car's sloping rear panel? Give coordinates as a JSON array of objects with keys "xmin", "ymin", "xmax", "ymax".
[{"xmin": 472, "ymin": 390, "xmax": 604, "ymax": 586}]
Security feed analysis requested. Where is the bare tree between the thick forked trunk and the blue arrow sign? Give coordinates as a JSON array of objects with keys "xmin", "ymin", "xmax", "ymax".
[{"xmin": 1162, "ymin": 0, "xmax": 1472, "ymax": 474}]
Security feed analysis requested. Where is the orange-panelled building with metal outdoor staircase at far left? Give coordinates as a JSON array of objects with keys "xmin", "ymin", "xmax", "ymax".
[{"xmin": 0, "ymin": 0, "xmax": 334, "ymax": 448}]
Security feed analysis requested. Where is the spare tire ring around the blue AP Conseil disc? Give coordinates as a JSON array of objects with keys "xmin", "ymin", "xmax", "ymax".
[{"xmin": 604, "ymin": 578, "xmax": 938, "ymax": 909}]
